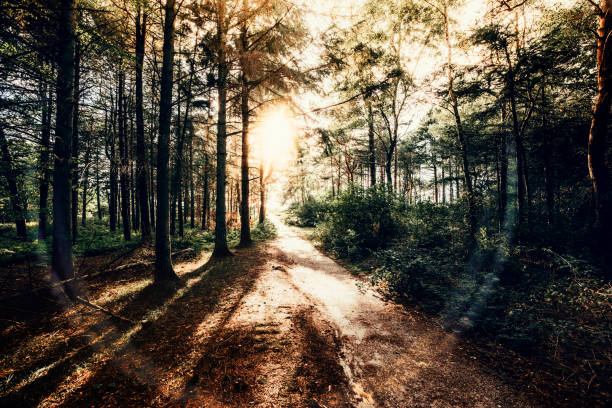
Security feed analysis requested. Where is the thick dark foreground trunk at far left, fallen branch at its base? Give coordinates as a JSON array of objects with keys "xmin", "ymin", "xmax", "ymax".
[{"xmin": 51, "ymin": 0, "xmax": 78, "ymax": 299}]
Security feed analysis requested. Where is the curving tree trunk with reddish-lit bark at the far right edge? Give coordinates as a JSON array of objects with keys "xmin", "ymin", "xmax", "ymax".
[{"xmin": 588, "ymin": 0, "xmax": 612, "ymax": 266}]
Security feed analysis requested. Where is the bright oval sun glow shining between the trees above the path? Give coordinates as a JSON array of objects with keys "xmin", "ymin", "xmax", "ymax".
[{"xmin": 253, "ymin": 106, "xmax": 297, "ymax": 169}]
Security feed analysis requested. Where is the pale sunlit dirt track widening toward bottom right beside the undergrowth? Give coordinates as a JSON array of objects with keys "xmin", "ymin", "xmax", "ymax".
[{"xmin": 270, "ymin": 219, "xmax": 531, "ymax": 408}]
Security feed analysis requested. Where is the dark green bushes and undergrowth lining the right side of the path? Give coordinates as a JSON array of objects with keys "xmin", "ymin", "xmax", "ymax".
[{"xmin": 289, "ymin": 187, "xmax": 612, "ymax": 404}]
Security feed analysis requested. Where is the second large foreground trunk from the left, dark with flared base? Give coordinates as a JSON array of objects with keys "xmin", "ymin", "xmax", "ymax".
[{"xmin": 154, "ymin": 0, "xmax": 178, "ymax": 282}]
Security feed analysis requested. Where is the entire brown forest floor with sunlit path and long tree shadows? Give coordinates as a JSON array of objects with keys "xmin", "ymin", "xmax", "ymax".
[{"xmin": 0, "ymin": 218, "xmax": 539, "ymax": 408}]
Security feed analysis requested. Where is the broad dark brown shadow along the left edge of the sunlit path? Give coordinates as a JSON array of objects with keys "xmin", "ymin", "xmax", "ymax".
[{"xmin": 44, "ymin": 247, "xmax": 266, "ymax": 407}]
